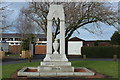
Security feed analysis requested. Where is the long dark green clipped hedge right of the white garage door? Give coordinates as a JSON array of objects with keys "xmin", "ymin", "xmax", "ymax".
[{"xmin": 82, "ymin": 46, "xmax": 120, "ymax": 58}]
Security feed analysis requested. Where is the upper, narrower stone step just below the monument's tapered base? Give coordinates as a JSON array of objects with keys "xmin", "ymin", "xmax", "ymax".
[{"xmin": 41, "ymin": 61, "xmax": 71, "ymax": 66}]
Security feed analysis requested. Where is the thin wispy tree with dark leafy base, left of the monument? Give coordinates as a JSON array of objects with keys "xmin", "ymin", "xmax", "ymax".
[{"xmin": 16, "ymin": 8, "xmax": 35, "ymax": 51}]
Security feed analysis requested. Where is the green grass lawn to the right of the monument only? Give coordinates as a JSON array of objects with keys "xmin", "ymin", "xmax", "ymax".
[{"xmin": 72, "ymin": 61, "xmax": 118, "ymax": 78}]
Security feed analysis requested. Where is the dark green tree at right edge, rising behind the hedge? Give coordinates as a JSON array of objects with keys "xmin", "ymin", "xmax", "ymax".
[{"xmin": 111, "ymin": 31, "xmax": 120, "ymax": 45}]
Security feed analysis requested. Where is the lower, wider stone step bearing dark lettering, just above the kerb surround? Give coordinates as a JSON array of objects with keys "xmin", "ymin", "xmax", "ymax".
[{"xmin": 38, "ymin": 66, "xmax": 74, "ymax": 72}]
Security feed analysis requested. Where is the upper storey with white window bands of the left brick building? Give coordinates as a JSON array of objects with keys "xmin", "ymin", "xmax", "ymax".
[{"xmin": 0, "ymin": 33, "xmax": 46, "ymax": 45}]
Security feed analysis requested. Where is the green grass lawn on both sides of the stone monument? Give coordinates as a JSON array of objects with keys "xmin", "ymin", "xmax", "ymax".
[{"xmin": 2, "ymin": 61, "xmax": 118, "ymax": 78}]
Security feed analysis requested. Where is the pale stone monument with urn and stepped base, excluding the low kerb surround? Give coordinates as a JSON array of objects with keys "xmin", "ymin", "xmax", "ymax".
[{"xmin": 39, "ymin": 5, "xmax": 74, "ymax": 72}]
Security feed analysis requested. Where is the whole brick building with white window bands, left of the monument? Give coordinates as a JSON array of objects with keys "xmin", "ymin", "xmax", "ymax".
[{"xmin": 0, "ymin": 33, "xmax": 46, "ymax": 54}]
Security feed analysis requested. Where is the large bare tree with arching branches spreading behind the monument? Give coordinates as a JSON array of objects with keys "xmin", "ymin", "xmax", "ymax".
[{"xmin": 22, "ymin": 2, "xmax": 117, "ymax": 40}]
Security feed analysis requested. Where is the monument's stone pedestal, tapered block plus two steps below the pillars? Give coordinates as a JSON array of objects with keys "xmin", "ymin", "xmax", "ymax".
[{"xmin": 38, "ymin": 54, "xmax": 74, "ymax": 72}]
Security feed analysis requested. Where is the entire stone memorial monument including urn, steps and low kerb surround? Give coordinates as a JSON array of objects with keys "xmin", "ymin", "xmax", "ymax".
[{"xmin": 18, "ymin": 5, "xmax": 94, "ymax": 77}]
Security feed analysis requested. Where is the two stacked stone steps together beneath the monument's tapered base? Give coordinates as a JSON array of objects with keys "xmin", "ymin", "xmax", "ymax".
[{"xmin": 38, "ymin": 61, "xmax": 74, "ymax": 72}]
